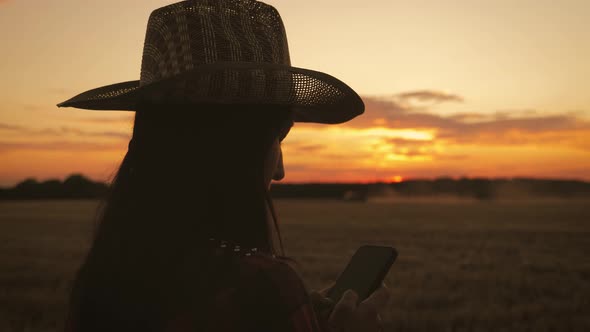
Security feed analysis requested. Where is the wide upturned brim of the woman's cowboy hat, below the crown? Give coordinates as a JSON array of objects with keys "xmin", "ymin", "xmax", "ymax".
[{"xmin": 57, "ymin": 62, "xmax": 365, "ymax": 124}]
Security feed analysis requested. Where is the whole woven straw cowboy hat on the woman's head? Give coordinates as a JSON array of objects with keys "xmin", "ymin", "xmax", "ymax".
[{"xmin": 57, "ymin": 0, "xmax": 364, "ymax": 123}]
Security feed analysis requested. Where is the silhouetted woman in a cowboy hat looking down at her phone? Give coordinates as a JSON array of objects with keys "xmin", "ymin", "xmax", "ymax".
[{"xmin": 58, "ymin": 0, "xmax": 388, "ymax": 332}]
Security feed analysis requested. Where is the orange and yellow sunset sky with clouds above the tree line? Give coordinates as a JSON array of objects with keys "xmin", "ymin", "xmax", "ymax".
[{"xmin": 0, "ymin": 0, "xmax": 590, "ymax": 186}]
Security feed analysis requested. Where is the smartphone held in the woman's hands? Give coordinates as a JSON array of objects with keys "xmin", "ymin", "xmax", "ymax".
[{"xmin": 327, "ymin": 245, "xmax": 397, "ymax": 303}]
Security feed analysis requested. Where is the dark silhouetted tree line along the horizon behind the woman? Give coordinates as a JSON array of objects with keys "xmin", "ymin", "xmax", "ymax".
[{"xmin": 0, "ymin": 174, "xmax": 590, "ymax": 201}]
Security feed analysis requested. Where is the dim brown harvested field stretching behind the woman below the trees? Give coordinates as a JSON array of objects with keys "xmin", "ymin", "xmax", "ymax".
[{"xmin": 0, "ymin": 200, "xmax": 590, "ymax": 331}]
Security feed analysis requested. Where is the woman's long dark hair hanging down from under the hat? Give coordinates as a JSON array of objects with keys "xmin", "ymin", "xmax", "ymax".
[{"xmin": 69, "ymin": 105, "xmax": 293, "ymax": 331}]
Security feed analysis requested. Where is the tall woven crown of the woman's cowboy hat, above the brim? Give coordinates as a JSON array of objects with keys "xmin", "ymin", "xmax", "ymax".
[{"xmin": 140, "ymin": 0, "xmax": 291, "ymax": 85}]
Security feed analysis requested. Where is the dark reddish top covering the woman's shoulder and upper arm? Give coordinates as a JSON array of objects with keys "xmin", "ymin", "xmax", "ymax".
[{"xmin": 65, "ymin": 241, "xmax": 330, "ymax": 332}]
